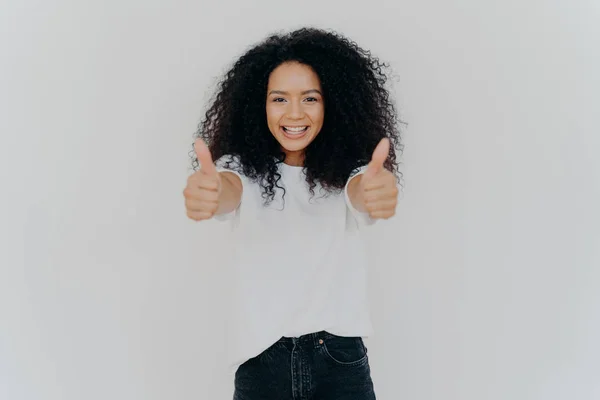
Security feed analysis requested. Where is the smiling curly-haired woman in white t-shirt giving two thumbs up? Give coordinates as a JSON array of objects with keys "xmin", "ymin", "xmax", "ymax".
[{"xmin": 184, "ymin": 29, "xmax": 401, "ymax": 400}]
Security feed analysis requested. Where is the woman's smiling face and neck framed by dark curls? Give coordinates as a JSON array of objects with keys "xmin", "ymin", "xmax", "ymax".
[{"xmin": 266, "ymin": 62, "xmax": 325, "ymax": 166}]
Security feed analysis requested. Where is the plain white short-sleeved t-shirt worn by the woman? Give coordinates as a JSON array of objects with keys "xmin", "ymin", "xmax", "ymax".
[{"xmin": 216, "ymin": 156, "xmax": 375, "ymax": 372}]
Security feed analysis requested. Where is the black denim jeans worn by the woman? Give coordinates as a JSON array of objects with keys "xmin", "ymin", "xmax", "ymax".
[{"xmin": 233, "ymin": 332, "xmax": 375, "ymax": 400}]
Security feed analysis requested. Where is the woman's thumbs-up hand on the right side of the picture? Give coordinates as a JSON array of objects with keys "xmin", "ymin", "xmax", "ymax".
[{"xmin": 349, "ymin": 139, "xmax": 398, "ymax": 219}]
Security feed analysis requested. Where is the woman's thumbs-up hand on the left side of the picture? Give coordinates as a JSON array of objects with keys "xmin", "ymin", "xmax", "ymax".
[{"xmin": 183, "ymin": 139, "xmax": 222, "ymax": 221}]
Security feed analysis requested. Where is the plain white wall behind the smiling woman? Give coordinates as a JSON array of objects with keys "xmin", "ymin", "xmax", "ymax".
[{"xmin": 0, "ymin": 0, "xmax": 600, "ymax": 400}]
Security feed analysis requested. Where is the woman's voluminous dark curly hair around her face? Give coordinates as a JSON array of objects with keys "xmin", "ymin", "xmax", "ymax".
[{"xmin": 190, "ymin": 28, "xmax": 402, "ymax": 203}]
